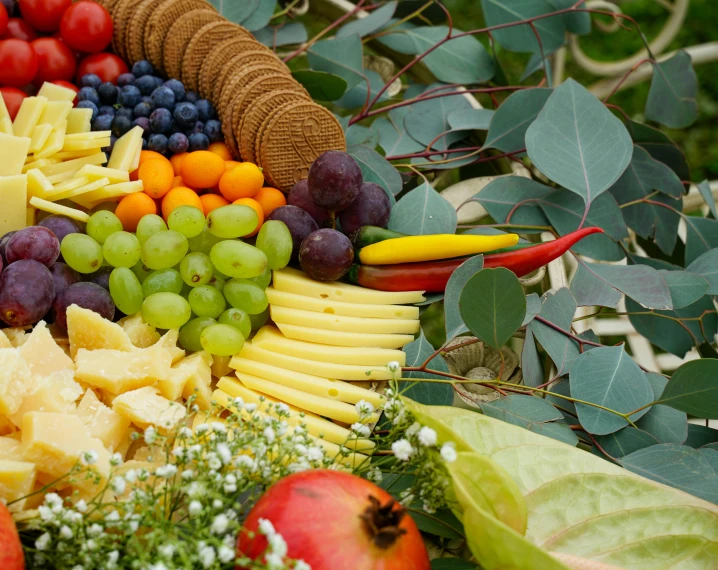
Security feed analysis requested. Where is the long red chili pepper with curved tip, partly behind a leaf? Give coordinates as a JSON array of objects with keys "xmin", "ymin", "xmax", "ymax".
[{"xmin": 348, "ymin": 228, "xmax": 603, "ymax": 293}]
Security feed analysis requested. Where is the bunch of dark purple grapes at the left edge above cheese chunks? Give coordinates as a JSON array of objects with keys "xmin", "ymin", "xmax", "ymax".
[{"xmin": 0, "ymin": 216, "xmax": 115, "ymax": 329}]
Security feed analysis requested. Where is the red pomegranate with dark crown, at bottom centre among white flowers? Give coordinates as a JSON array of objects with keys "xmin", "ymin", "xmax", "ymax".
[{"xmin": 242, "ymin": 469, "xmax": 430, "ymax": 570}]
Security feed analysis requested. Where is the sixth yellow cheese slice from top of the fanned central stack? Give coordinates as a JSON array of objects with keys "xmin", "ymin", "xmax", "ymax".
[{"xmin": 235, "ymin": 342, "xmax": 391, "ymax": 381}]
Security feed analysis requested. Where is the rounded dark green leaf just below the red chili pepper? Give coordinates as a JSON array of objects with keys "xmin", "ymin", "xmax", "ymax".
[{"xmin": 459, "ymin": 267, "xmax": 526, "ymax": 349}]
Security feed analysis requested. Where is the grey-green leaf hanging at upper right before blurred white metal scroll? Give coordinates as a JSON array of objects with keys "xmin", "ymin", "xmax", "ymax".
[{"xmin": 646, "ymin": 50, "xmax": 698, "ymax": 129}]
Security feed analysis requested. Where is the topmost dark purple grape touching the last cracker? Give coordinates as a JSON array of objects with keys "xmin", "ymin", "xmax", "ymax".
[{"xmin": 307, "ymin": 150, "xmax": 362, "ymax": 212}]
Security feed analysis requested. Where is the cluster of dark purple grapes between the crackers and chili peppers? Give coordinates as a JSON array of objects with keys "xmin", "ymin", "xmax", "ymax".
[{"xmin": 268, "ymin": 151, "xmax": 391, "ymax": 281}]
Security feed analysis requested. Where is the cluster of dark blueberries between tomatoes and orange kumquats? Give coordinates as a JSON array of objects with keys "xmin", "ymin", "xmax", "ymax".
[{"xmin": 77, "ymin": 61, "xmax": 223, "ymax": 154}]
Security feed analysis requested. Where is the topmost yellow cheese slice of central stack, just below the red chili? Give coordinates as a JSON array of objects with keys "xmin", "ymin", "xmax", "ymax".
[{"xmin": 273, "ymin": 268, "xmax": 426, "ymax": 305}]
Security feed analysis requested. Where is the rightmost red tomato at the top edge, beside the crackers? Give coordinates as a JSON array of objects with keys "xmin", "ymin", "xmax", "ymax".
[{"xmin": 60, "ymin": 2, "xmax": 112, "ymax": 53}]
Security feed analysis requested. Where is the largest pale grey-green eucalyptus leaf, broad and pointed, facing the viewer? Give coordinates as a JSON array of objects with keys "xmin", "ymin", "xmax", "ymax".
[{"xmin": 526, "ymin": 79, "xmax": 633, "ymax": 204}]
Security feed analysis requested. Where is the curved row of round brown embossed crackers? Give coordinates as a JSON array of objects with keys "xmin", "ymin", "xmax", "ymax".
[{"xmin": 97, "ymin": 0, "xmax": 346, "ymax": 191}]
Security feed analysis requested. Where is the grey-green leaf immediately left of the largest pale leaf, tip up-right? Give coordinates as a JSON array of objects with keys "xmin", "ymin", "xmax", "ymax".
[{"xmin": 484, "ymin": 88, "xmax": 552, "ymax": 152}]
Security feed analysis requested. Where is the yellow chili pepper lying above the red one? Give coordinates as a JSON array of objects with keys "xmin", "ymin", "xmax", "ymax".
[{"xmin": 359, "ymin": 234, "xmax": 519, "ymax": 265}]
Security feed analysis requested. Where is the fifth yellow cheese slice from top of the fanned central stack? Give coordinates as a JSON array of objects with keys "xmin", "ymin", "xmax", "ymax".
[{"xmin": 252, "ymin": 326, "xmax": 406, "ymax": 366}]
